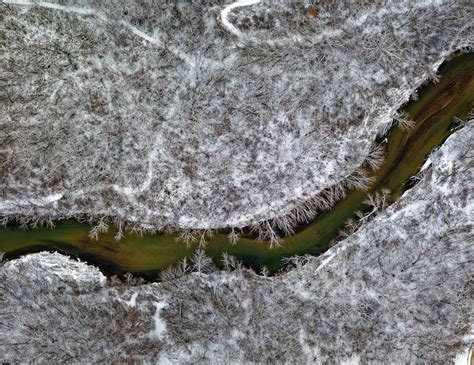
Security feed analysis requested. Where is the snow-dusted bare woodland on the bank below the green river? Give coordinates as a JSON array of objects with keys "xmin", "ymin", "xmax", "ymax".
[{"xmin": 0, "ymin": 120, "xmax": 474, "ymax": 364}]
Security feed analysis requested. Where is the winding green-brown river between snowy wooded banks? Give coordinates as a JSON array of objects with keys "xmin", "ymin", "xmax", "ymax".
[{"xmin": 0, "ymin": 53, "xmax": 474, "ymax": 278}]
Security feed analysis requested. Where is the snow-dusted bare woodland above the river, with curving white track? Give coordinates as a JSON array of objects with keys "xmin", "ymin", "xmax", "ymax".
[{"xmin": 0, "ymin": 0, "xmax": 473, "ymax": 229}]
